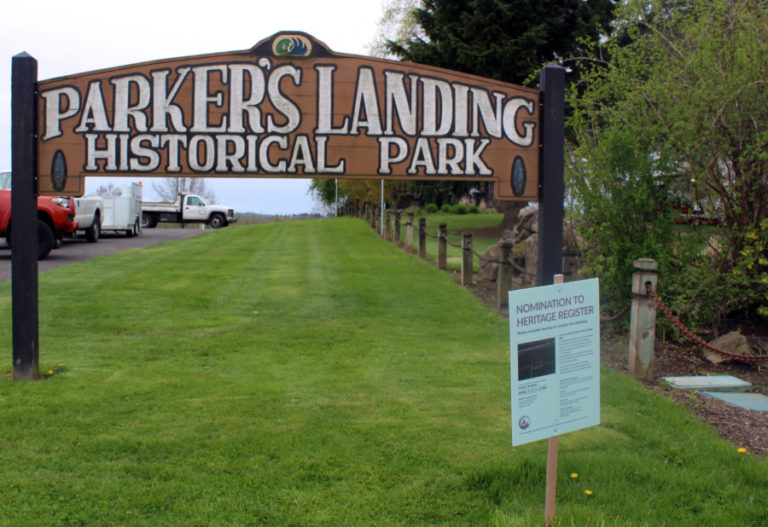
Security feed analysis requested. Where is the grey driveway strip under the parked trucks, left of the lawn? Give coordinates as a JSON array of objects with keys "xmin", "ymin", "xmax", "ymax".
[{"xmin": 0, "ymin": 225, "xmax": 206, "ymax": 282}]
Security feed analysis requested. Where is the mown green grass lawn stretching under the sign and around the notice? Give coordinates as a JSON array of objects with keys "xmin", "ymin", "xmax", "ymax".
[{"xmin": 0, "ymin": 218, "xmax": 768, "ymax": 527}]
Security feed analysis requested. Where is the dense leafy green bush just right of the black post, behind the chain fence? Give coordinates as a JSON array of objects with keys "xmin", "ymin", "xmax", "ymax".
[{"xmin": 566, "ymin": 130, "xmax": 686, "ymax": 309}]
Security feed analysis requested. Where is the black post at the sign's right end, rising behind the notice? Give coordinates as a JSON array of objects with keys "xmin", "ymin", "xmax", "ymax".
[{"xmin": 538, "ymin": 64, "xmax": 565, "ymax": 285}]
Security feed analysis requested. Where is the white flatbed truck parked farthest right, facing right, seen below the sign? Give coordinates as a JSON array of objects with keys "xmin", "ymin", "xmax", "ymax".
[{"xmin": 141, "ymin": 194, "xmax": 237, "ymax": 229}]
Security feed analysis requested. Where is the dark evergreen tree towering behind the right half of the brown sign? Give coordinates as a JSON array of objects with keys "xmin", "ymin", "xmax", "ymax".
[{"xmin": 388, "ymin": 0, "xmax": 614, "ymax": 216}]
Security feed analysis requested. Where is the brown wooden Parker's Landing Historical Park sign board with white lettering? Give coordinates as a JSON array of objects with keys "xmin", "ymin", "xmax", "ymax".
[{"xmin": 37, "ymin": 33, "xmax": 540, "ymax": 200}]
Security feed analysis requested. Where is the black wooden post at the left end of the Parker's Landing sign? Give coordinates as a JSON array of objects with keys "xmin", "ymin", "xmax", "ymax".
[{"xmin": 10, "ymin": 53, "xmax": 40, "ymax": 380}]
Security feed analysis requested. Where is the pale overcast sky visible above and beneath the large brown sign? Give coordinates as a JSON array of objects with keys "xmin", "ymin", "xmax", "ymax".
[{"xmin": 0, "ymin": 0, "xmax": 383, "ymax": 214}]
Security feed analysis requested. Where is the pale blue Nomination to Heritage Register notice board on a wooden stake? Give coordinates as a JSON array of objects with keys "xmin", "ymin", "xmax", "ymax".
[{"xmin": 509, "ymin": 279, "xmax": 600, "ymax": 446}]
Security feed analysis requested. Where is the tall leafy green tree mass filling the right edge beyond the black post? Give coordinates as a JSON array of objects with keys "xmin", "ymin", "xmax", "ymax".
[{"xmin": 568, "ymin": 0, "xmax": 768, "ymax": 325}]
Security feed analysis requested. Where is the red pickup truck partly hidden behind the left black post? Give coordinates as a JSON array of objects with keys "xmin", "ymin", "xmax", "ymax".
[{"xmin": 0, "ymin": 172, "xmax": 77, "ymax": 260}]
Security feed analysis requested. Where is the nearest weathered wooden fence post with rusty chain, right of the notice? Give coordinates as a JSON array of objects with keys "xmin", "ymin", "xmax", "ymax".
[{"xmin": 629, "ymin": 258, "xmax": 659, "ymax": 380}]
